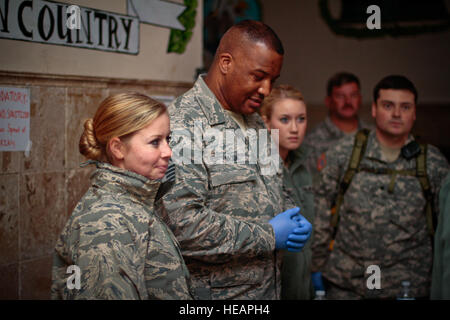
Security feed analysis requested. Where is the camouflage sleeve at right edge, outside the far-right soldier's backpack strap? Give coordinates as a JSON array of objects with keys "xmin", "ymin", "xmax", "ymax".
[{"xmin": 427, "ymin": 145, "xmax": 449, "ymax": 215}]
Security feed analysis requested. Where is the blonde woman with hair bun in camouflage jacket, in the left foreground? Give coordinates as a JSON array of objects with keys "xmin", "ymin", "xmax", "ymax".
[{"xmin": 52, "ymin": 93, "xmax": 191, "ymax": 299}]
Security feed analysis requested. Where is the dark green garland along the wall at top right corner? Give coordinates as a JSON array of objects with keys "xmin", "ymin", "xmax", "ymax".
[{"xmin": 319, "ymin": 0, "xmax": 450, "ymax": 39}]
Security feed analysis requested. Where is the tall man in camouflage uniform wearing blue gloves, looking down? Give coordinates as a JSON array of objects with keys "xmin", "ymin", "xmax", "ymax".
[{"xmin": 156, "ymin": 20, "xmax": 311, "ymax": 299}]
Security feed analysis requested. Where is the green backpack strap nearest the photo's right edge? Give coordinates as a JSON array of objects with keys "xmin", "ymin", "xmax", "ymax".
[{"xmin": 416, "ymin": 144, "xmax": 437, "ymax": 237}]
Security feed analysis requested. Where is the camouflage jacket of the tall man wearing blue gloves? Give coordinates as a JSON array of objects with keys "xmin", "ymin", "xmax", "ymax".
[{"xmin": 163, "ymin": 76, "xmax": 293, "ymax": 299}]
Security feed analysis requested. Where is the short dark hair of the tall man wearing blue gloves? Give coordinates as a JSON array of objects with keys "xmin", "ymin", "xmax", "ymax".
[{"xmin": 233, "ymin": 20, "xmax": 284, "ymax": 55}]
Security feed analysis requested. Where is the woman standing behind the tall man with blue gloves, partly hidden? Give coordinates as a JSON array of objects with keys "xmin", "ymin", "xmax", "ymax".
[{"xmin": 261, "ymin": 85, "xmax": 314, "ymax": 300}]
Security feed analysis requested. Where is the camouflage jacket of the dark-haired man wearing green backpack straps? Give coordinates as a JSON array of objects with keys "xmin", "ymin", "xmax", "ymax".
[{"xmin": 312, "ymin": 131, "xmax": 449, "ymax": 298}]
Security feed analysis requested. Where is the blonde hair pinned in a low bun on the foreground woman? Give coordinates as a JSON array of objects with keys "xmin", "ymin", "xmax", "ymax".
[{"xmin": 79, "ymin": 92, "xmax": 167, "ymax": 162}]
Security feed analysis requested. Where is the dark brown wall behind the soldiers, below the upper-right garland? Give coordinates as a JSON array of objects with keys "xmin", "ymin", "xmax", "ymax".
[{"xmin": 263, "ymin": 0, "xmax": 450, "ymax": 107}]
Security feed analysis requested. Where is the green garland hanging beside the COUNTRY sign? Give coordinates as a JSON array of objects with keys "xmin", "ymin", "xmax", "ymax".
[{"xmin": 167, "ymin": 0, "xmax": 198, "ymax": 53}]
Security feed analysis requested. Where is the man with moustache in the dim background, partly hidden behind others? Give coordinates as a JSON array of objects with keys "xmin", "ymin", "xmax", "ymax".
[{"xmin": 304, "ymin": 72, "xmax": 368, "ymax": 181}]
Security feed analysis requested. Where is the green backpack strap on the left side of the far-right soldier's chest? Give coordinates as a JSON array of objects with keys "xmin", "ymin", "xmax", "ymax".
[{"xmin": 331, "ymin": 129, "xmax": 370, "ymax": 230}]
